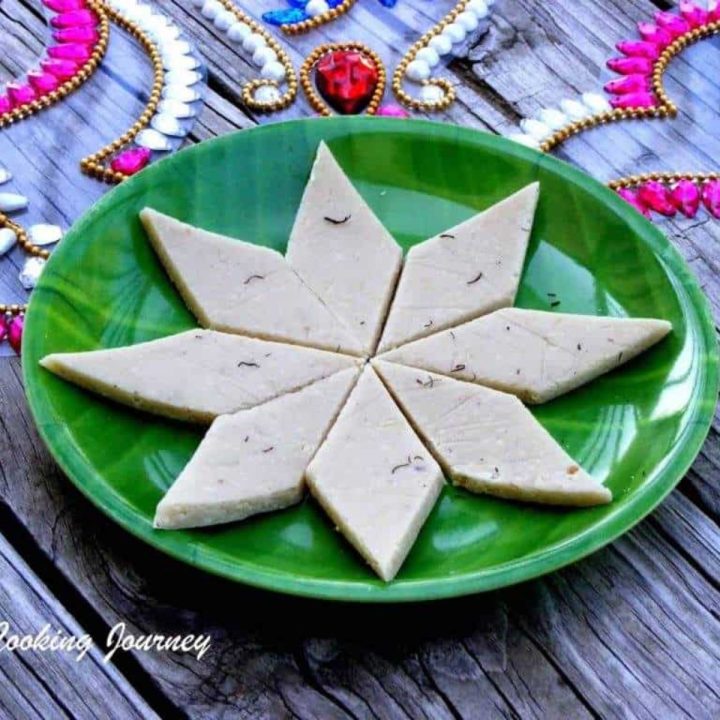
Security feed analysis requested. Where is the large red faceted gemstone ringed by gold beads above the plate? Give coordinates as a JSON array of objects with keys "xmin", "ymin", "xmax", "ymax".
[{"xmin": 315, "ymin": 50, "xmax": 378, "ymax": 115}]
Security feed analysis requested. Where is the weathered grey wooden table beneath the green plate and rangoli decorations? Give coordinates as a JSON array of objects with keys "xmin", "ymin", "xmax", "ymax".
[{"xmin": 0, "ymin": 0, "xmax": 720, "ymax": 720}]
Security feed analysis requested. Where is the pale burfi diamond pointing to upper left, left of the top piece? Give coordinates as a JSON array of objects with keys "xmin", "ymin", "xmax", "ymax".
[{"xmin": 140, "ymin": 208, "xmax": 363, "ymax": 355}]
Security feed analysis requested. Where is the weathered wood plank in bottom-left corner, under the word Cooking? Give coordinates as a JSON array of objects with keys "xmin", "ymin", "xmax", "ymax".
[{"xmin": 0, "ymin": 524, "xmax": 157, "ymax": 720}]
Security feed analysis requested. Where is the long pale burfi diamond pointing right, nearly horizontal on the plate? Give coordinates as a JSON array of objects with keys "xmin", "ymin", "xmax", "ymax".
[{"xmin": 380, "ymin": 308, "xmax": 672, "ymax": 403}]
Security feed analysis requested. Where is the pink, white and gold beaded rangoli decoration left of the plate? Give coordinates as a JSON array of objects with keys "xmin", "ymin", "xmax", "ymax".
[{"xmin": 0, "ymin": 0, "xmax": 203, "ymax": 353}]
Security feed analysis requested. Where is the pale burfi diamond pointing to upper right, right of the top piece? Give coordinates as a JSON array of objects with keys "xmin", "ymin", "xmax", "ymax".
[{"xmin": 379, "ymin": 183, "xmax": 540, "ymax": 352}]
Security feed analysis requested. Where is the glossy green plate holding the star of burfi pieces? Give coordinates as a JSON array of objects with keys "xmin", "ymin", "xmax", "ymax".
[{"xmin": 23, "ymin": 118, "xmax": 718, "ymax": 601}]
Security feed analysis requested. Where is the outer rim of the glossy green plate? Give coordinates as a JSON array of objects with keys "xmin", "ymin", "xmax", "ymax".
[{"xmin": 22, "ymin": 116, "xmax": 720, "ymax": 603}]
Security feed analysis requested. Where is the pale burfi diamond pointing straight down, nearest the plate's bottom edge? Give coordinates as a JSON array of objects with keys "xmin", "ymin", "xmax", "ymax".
[{"xmin": 306, "ymin": 366, "xmax": 443, "ymax": 581}]
